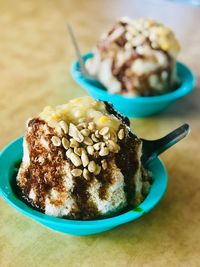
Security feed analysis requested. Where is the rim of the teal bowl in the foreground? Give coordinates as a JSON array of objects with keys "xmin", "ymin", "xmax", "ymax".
[{"xmin": 0, "ymin": 136, "xmax": 168, "ymax": 229}]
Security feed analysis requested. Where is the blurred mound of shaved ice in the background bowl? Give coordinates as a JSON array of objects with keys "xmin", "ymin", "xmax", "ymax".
[{"xmin": 86, "ymin": 17, "xmax": 180, "ymax": 96}]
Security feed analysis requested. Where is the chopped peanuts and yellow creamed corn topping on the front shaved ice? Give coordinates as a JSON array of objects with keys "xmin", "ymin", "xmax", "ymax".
[{"xmin": 39, "ymin": 100, "xmax": 123, "ymax": 180}]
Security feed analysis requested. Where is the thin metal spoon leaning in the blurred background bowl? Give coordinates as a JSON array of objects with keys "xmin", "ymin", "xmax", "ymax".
[{"xmin": 67, "ymin": 24, "xmax": 106, "ymax": 90}]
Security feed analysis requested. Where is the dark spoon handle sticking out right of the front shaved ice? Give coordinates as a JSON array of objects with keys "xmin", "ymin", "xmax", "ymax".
[{"xmin": 142, "ymin": 123, "xmax": 190, "ymax": 164}]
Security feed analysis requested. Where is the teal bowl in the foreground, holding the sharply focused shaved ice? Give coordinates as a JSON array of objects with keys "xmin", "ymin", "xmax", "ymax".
[{"xmin": 0, "ymin": 137, "xmax": 167, "ymax": 236}]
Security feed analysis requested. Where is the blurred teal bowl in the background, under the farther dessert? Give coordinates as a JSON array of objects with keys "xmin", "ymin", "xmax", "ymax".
[{"xmin": 71, "ymin": 53, "xmax": 195, "ymax": 118}]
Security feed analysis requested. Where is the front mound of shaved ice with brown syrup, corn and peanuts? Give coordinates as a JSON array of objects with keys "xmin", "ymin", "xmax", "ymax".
[{"xmin": 17, "ymin": 97, "xmax": 150, "ymax": 220}]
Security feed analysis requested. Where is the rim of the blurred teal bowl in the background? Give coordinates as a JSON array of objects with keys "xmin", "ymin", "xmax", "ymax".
[{"xmin": 70, "ymin": 52, "xmax": 196, "ymax": 103}]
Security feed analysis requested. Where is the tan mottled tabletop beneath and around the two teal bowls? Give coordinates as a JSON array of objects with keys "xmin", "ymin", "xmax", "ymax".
[{"xmin": 0, "ymin": 0, "xmax": 200, "ymax": 267}]
